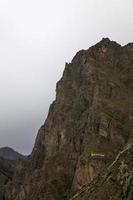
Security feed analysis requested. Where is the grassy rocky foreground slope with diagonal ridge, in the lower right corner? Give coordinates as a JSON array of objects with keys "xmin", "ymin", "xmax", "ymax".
[{"xmin": 71, "ymin": 139, "xmax": 133, "ymax": 200}]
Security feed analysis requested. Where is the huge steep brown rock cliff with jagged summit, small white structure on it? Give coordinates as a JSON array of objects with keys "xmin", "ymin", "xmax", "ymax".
[{"xmin": 5, "ymin": 38, "xmax": 133, "ymax": 200}]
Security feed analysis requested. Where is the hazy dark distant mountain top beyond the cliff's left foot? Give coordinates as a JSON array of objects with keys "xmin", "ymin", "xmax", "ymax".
[{"xmin": 0, "ymin": 147, "xmax": 26, "ymax": 161}]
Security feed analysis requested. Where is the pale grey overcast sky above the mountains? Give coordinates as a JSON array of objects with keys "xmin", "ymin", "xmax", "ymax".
[{"xmin": 0, "ymin": 0, "xmax": 133, "ymax": 154}]
